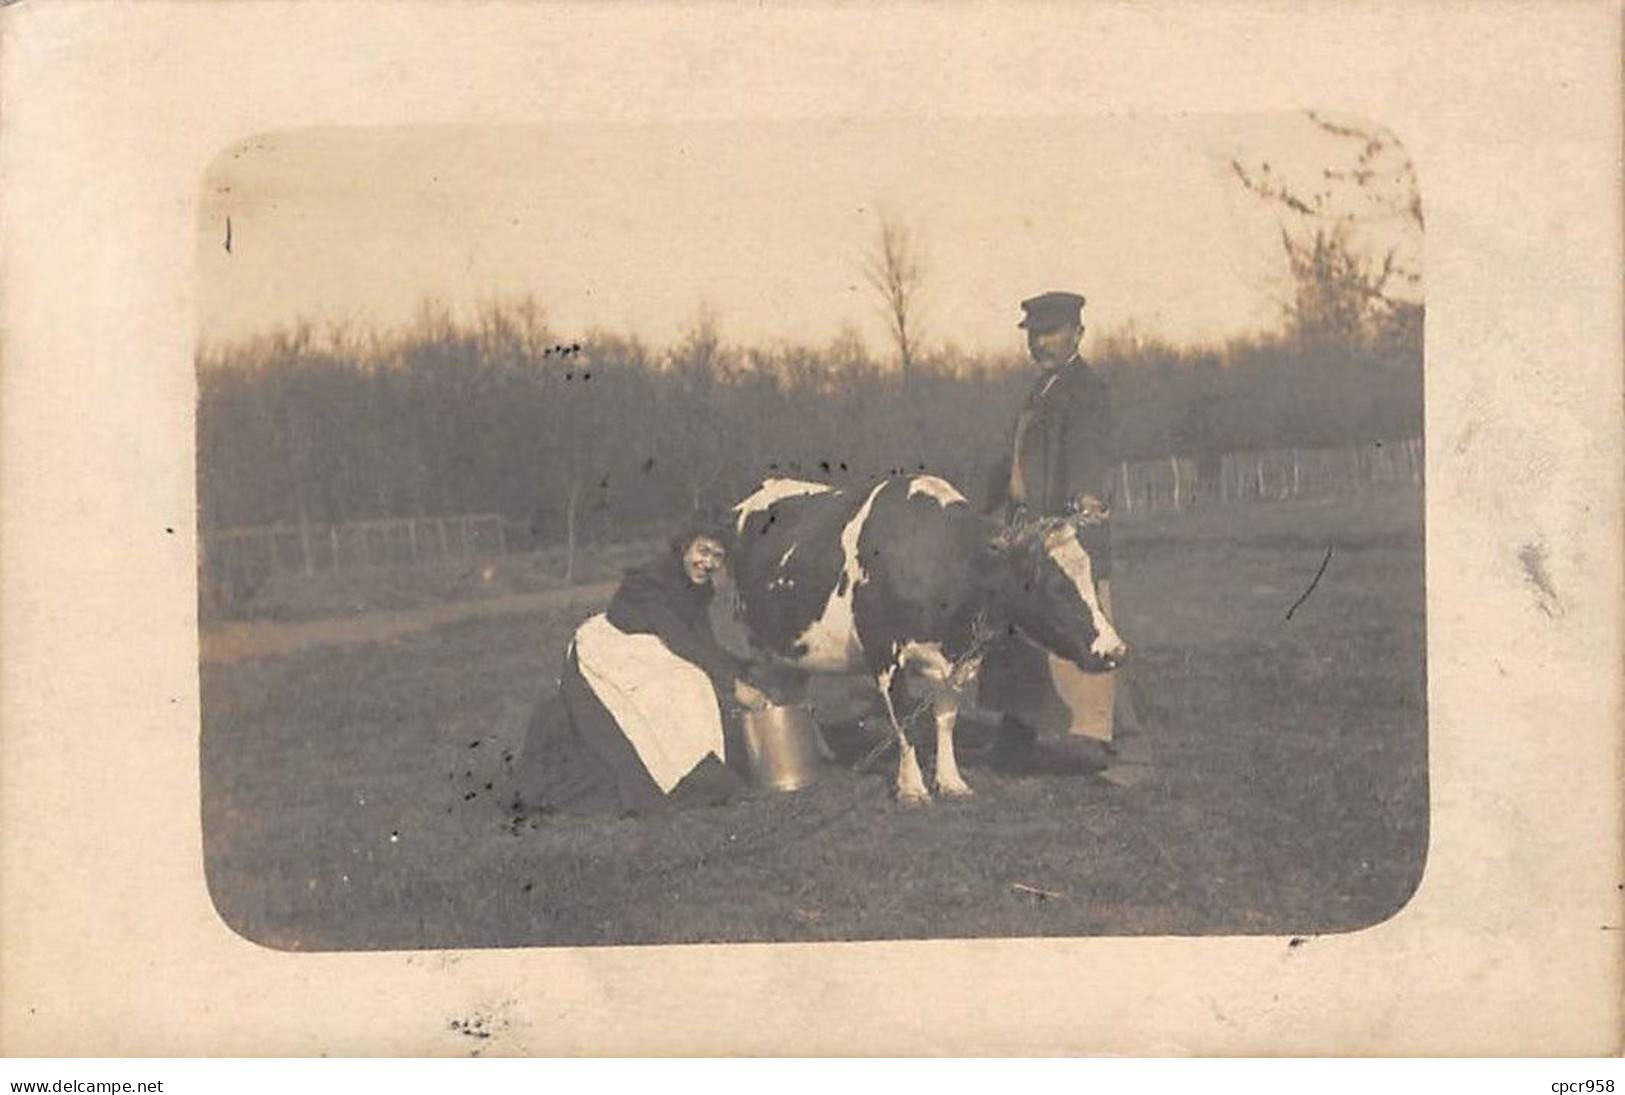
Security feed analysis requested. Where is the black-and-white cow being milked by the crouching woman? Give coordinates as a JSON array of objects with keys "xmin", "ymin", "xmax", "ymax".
[{"xmin": 726, "ymin": 474, "xmax": 1125, "ymax": 804}]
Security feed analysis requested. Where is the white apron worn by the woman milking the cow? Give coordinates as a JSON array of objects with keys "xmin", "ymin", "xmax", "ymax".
[{"xmin": 575, "ymin": 612, "xmax": 726, "ymax": 794}]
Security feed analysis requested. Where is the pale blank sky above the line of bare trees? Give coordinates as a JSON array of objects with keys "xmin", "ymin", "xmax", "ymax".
[{"xmin": 198, "ymin": 114, "xmax": 1417, "ymax": 353}]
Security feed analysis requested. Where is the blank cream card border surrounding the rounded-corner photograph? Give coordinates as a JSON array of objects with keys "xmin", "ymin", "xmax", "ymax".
[{"xmin": 0, "ymin": 2, "xmax": 1625, "ymax": 1056}]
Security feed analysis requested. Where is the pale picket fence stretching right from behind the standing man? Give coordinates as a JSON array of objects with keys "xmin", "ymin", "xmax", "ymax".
[{"xmin": 1113, "ymin": 437, "xmax": 1424, "ymax": 513}]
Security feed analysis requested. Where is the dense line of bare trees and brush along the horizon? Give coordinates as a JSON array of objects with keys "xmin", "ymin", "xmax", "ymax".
[{"xmin": 198, "ymin": 292, "xmax": 1422, "ymax": 544}]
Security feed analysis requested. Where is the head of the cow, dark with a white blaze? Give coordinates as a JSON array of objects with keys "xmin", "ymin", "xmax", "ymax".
[{"xmin": 991, "ymin": 507, "xmax": 1126, "ymax": 671}]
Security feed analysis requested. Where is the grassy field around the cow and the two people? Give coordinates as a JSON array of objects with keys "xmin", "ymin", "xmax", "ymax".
[{"xmin": 202, "ymin": 492, "xmax": 1428, "ymax": 950}]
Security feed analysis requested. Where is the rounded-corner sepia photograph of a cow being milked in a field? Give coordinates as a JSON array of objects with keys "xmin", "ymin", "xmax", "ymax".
[{"xmin": 197, "ymin": 110, "xmax": 1428, "ymax": 950}]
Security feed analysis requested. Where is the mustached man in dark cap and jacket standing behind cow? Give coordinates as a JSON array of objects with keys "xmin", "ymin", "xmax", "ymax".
[{"xmin": 980, "ymin": 292, "xmax": 1149, "ymax": 785}]
